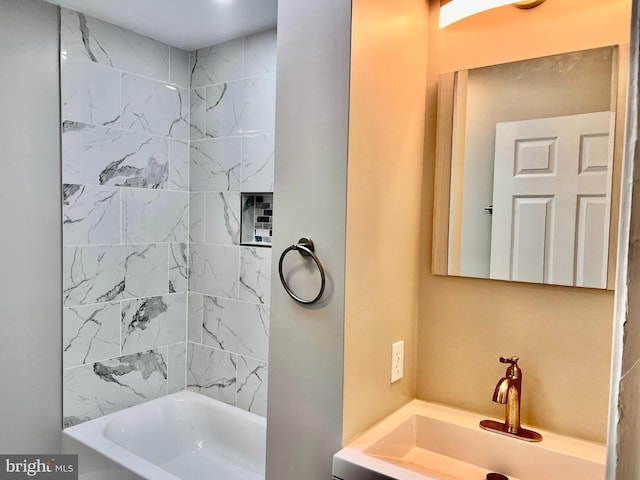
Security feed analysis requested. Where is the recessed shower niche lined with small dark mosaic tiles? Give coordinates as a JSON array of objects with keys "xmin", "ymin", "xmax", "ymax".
[{"xmin": 240, "ymin": 193, "xmax": 273, "ymax": 247}]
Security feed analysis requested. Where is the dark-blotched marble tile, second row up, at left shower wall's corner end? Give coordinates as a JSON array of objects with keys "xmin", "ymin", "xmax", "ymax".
[{"xmin": 121, "ymin": 293, "xmax": 187, "ymax": 354}]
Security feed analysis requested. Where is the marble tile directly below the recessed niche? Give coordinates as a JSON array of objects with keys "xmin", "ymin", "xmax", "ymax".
[{"xmin": 239, "ymin": 247, "xmax": 271, "ymax": 305}]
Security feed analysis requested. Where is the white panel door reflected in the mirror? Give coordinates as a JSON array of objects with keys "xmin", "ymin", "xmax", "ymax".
[{"xmin": 490, "ymin": 112, "xmax": 614, "ymax": 288}]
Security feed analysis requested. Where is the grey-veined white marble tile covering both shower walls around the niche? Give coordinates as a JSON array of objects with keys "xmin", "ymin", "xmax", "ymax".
[{"xmin": 61, "ymin": 13, "xmax": 276, "ymax": 425}]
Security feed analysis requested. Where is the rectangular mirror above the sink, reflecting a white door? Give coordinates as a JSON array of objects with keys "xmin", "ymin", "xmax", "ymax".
[{"xmin": 434, "ymin": 46, "xmax": 623, "ymax": 288}]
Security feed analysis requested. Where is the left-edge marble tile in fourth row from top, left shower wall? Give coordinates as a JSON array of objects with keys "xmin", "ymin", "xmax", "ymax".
[{"xmin": 62, "ymin": 184, "xmax": 120, "ymax": 245}]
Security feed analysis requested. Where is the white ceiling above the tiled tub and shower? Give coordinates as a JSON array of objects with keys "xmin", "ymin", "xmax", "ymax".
[{"xmin": 46, "ymin": 0, "xmax": 278, "ymax": 50}]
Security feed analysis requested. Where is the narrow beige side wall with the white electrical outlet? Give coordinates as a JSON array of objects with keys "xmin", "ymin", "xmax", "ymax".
[{"xmin": 343, "ymin": 0, "xmax": 427, "ymax": 442}]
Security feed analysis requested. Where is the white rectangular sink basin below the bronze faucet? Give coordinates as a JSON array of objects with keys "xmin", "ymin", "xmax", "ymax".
[{"xmin": 333, "ymin": 400, "xmax": 605, "ymax": 480}]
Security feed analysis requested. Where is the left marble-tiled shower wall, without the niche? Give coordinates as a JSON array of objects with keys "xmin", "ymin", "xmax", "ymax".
[{"xmin": 61, "ymin": 9, "xmax": 190, "ymax": 426}]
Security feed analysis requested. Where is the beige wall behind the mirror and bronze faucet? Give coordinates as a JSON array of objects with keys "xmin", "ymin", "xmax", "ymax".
[{"xmin": 417, "ymin": 0, "xmax": 631, "ymax": 442}]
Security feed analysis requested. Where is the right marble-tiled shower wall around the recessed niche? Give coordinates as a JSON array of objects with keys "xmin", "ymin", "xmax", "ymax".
[{"xmin": 187, "ymin": 29, "xmax": 277, "ymax": 415}]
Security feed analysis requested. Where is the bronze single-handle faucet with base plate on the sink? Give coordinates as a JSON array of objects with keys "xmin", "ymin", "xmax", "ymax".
[{"xmin": 480, "ymin": 357, "xmax": 542, "ymax": 442}]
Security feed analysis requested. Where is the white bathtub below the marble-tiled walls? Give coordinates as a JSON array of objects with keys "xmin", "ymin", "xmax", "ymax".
[{"xmin": 62, "ymin": 392, "xmax": 266, "ymax": 480}]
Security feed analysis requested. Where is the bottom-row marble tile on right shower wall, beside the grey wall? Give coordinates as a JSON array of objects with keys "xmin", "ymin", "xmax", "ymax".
[{"xmin": 236, "ymin": 356, "xmax": 269, "ymax": 417}]
